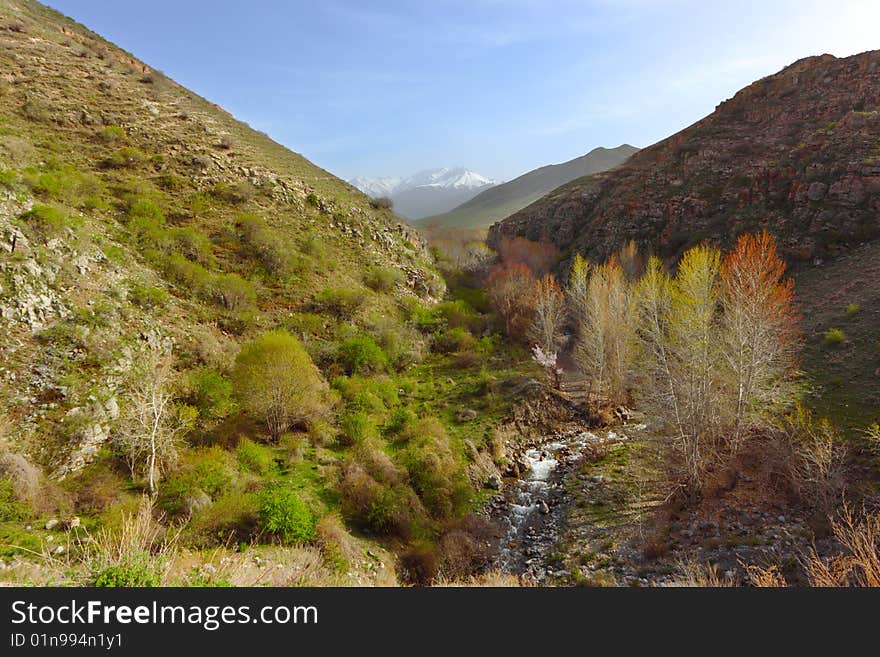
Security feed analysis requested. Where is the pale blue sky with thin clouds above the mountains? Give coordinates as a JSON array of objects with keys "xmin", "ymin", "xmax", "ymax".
[{"xmin": 44, "ymin": 0, "xmax": 880, "ymax": 180}]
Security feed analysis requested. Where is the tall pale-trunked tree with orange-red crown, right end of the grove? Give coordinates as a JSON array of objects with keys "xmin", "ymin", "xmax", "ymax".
[{"xmin": 720, "ymin": 231, "xmax": 799, "ymax": 451}]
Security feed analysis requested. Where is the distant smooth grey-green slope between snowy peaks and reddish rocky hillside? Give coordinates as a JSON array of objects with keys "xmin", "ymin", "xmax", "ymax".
[{"xmin": 419, "ymin": 144, "xmax": 638, "ymax": 228}]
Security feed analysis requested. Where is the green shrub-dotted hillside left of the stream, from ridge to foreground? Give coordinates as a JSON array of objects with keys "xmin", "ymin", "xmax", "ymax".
[{"xmin": 0, "ymin": 0, "xmax": 536, "ymax": 584}]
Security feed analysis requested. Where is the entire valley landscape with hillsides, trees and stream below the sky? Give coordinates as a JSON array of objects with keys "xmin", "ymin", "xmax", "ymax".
[{"xmin": 0, "ymin": 0, "xmax": 880, "ymax": 587}]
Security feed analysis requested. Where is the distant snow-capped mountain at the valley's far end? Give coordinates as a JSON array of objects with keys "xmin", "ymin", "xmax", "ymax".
[{"xmin": 349, "ymin": 167, "xmax": 500, "ymax": 219}]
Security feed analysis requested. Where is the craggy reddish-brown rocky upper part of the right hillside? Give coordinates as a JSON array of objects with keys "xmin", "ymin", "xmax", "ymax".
[{"xmin": 490, "ymin": 51, "xmax": 880, "ymax": 259}]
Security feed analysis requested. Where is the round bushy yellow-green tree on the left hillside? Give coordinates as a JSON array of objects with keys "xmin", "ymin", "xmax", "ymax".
[{"xmin": 232, "ymin": 330, "xmax": 327, "ymax": 440}]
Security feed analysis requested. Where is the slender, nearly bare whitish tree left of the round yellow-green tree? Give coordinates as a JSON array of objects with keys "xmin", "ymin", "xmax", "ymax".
[{"xmin": 114, "ymin": 340, "xmax": 197, "ymax": 495}]
